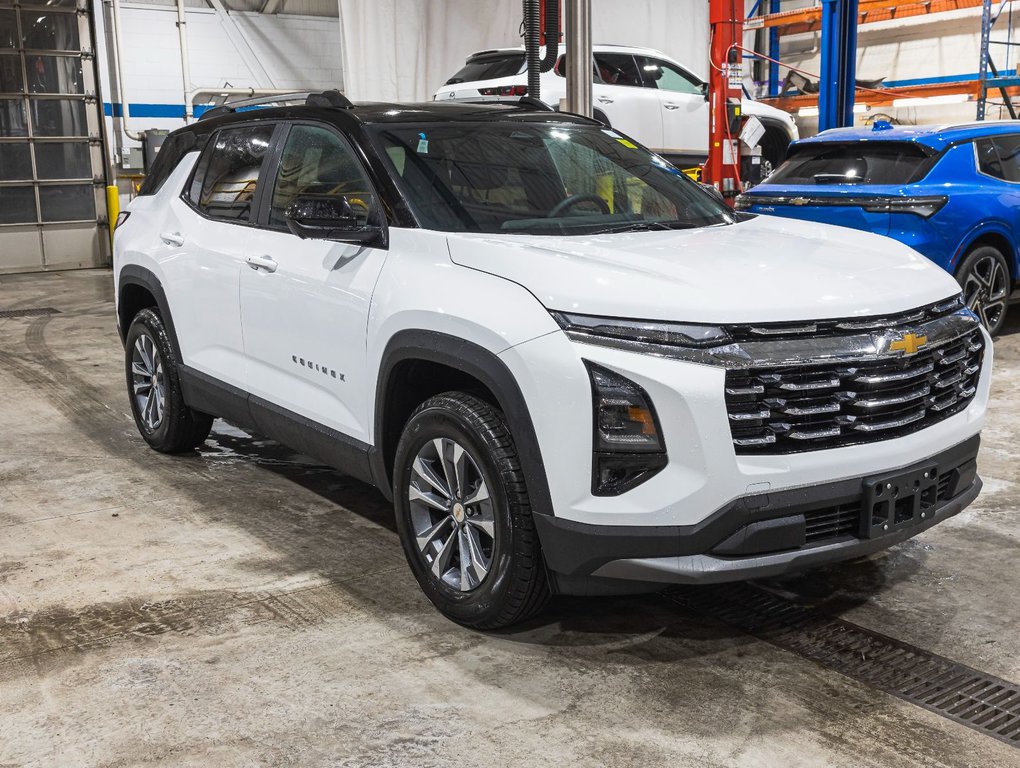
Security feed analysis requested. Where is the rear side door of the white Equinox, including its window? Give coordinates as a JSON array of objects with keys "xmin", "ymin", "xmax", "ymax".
[{"xmin": 158, "ymin": 122, "xmax": 275, "ymax": 388}]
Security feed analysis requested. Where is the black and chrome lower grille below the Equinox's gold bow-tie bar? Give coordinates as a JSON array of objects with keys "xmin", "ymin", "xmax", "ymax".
[{"xmin": 726, "ymin": 328, "xmax": 984, "ymax": 454}]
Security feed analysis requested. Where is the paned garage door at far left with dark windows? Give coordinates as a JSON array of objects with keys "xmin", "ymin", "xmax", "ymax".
[{"xmin": 0, "ymin": 0, "xmax": 107, "ymax": 272}]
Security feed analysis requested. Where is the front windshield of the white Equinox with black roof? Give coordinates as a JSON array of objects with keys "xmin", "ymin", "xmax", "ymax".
[{"xmin": 375, "ymin": 120, "xmax": 736, "ymax": 235}]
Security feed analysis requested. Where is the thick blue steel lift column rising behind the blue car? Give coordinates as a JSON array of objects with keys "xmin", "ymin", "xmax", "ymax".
[{"xmin": 818, "ymin": 0, "xmax": 857, "ymax": 131}]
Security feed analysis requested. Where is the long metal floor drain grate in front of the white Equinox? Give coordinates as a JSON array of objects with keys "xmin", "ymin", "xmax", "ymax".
[{"xmin": 667, "ymin": 584, "xmax": 1020, "ymax": 748}]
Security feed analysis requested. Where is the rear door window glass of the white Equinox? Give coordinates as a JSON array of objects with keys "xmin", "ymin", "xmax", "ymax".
[{"xmin": 189, "ymin": 125, "xmax": 274, "ymax": 221}]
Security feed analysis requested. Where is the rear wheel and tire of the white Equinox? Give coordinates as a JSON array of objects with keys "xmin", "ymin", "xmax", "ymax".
[{"xmin": 124, "ymin": 309, "xmax": 213, "ymax": 453}]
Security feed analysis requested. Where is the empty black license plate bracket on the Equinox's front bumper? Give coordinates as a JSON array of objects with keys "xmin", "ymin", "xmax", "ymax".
[{"xmin": 861, "ymin": 464, "xmax": 938, "ymax": 539}]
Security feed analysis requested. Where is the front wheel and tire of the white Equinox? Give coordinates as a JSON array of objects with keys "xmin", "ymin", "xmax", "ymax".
[{"xmin": 393, "ymin": 392, "xmax": 550, "ymax": 629}]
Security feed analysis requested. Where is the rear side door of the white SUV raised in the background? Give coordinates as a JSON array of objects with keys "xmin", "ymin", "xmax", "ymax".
[{"xmin": 592, "ymin": 53, "xmax": 664, "ymax": 151}]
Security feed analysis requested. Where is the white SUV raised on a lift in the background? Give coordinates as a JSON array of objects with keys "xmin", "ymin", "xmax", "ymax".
[{"xmin": 432, "ymin": 45, "xmax": 799, "ymax": 175}]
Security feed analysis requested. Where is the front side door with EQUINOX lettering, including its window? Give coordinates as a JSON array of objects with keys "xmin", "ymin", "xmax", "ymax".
[{"xmin": 241, "ymin": 119, "xmax": 387, "ymax": 444}]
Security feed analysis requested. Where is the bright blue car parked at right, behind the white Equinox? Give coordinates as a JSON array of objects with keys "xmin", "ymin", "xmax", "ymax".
[{"xmin": 736, "ymin": 120, "xmax": 1020, "ymax": 335}]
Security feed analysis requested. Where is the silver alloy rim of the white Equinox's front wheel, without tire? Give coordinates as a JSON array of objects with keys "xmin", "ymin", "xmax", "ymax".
[{"xmin": 407, "ymin": 438, "xmax": 496, "ymax": 592}]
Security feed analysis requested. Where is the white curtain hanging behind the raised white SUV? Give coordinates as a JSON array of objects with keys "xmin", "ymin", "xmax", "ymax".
[{"xmin": 338, "ymin": 0, "xmax": 708, "ymax": 101}]
